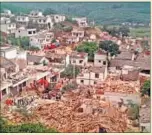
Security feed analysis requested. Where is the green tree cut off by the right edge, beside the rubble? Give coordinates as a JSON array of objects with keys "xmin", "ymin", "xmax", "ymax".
[{"xmin": 141, "ymin": 80, "xmax": 150, "ymax": 96}]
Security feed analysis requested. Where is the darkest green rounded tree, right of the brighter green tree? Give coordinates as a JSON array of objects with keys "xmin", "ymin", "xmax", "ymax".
[{"xmin": 99, "ymin": 40, "xmax": 119, "ymax": 56}]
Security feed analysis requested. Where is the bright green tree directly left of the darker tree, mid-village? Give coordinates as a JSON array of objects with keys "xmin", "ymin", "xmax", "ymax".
[{"xmin": 76, "ymin": 42, "xmax": 98, "ymax": 61}]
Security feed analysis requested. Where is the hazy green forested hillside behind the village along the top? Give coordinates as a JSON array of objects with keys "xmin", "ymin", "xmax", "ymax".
[{"xmin": 1, "ymin": 2, "xmax": 150, "ymax": 24}]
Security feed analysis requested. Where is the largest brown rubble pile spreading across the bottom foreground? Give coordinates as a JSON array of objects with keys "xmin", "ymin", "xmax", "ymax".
[{"xmin": 1, "ymin": 89, "xmax": 127, "ymax": 133}]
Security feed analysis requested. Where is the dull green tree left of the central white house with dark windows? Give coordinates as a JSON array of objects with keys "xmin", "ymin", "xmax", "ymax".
[{"xmin": 61, "ymin": 65, "xmax": 80, "ymax": 79}]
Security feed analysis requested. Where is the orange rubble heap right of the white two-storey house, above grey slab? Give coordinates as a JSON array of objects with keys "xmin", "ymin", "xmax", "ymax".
[{"xmin": 97, "ymin": 78, "xmax": 140, "ymax": 94}]
